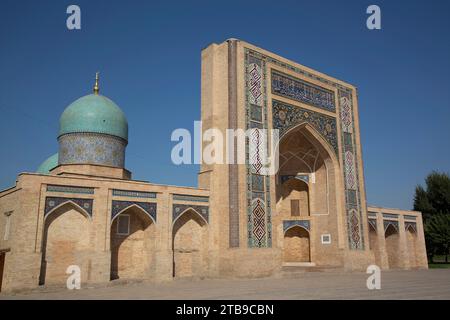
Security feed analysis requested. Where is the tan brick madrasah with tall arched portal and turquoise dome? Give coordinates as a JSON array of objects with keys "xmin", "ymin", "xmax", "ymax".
[{"xmin": 0, "ymin": 39, "xmax": 427, "ymax": 292}]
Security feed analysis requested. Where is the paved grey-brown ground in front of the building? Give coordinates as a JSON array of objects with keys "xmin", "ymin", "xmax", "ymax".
[{"xmin": 0, "ymin": 269, "xmax": 450, "ymax": 300}]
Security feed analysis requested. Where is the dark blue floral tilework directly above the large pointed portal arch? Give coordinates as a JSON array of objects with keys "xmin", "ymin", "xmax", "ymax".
[{"xmin": 272, "ymin": 99, "xmax": 338, "ymax": 154}]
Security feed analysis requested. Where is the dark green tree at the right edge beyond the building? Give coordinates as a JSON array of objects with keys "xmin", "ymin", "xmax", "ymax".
[{"xmin": 414, "ymin": 171, "xmax": 450, "ymax": 262}]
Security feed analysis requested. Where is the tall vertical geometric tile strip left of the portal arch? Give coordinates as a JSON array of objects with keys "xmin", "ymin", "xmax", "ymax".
[{"xmin": 245, "ymin": 49, "xmax": 272, "ymax": 248}]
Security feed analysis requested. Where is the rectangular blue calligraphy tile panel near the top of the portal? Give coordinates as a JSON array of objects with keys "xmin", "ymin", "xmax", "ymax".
[{"xmin": 272, "ymin": 71, "xmax": 336, "ymax": 112}]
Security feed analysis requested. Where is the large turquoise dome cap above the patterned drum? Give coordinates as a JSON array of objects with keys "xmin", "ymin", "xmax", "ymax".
[{"xmin": 58, "ymin": 94, "xmax": 128, "ymax": 141}]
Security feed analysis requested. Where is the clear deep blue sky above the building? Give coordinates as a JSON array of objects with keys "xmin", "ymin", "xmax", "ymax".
[{"xmin": 0, "ymin": 0, "xmax": 450, "ymax": 209}]
